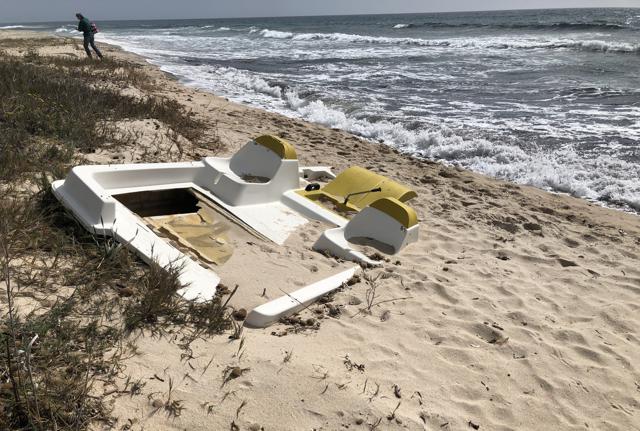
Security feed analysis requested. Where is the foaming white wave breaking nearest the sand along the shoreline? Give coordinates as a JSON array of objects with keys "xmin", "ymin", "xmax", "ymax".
[{"xmin": 195, "ymin": 68, "xmax": 640, "ymax": 211}]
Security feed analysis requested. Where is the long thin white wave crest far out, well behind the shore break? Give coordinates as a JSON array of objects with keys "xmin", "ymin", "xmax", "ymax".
[{"xmin": 255, "ymin": 29, "xmax": 640, "ymax": 54}]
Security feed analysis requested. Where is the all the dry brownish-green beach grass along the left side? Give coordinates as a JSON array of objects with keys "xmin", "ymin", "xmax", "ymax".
[{"xmin": 0, "ymin": 48, "xmax": 230, "ymax": 430}]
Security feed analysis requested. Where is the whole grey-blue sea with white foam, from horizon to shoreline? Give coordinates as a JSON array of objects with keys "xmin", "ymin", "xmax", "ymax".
[{"xmin": 7, "ymin": 9, "xmax": 640, "ymax": 212}]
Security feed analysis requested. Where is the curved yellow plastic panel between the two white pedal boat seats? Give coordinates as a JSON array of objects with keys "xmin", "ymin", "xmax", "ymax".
[{"xmin": 321, "ymin": 166, "xmax": 417, "ymax": 209}]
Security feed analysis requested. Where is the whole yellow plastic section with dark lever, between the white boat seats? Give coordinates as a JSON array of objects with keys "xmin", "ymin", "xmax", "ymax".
[{"xmin": 298, "ymin": 166, "xmax": 417, "ymax": 212}]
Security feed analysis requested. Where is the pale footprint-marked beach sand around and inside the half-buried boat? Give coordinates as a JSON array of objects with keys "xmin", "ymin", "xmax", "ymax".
[{"xmin": 0, "ymin": 32, "xmax": 640, "ymax": 430}]
